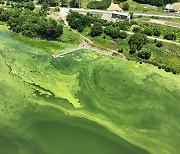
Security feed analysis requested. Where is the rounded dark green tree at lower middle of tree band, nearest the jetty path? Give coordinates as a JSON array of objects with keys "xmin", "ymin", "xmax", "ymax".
[{"xmin": 90, "ymin": 22, "xmax": 103, "ymax": 37}]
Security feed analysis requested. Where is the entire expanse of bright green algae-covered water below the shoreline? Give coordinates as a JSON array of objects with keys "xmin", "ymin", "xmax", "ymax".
[{"xmin": 0, "ymin": 29, "xmax": 180, "ymax": 154}]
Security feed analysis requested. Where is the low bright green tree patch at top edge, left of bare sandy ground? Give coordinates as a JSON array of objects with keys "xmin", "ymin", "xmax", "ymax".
[{"xmin": 87, "ymin": 0, "xmax": 111, "ymax": 10}]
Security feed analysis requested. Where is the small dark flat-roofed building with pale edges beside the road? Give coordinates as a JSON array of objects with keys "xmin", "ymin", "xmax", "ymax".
[{"xmin": 111, "ymin": 11, "xmax": 130, "ymax": 21}]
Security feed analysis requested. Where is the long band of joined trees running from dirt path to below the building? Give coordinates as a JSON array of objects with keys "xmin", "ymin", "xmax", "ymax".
[{"xmin": 66, "ymin": 11, "xmax": 131, "ymax": 39}]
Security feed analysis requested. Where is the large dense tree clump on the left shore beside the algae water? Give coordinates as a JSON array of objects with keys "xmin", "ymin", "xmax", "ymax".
[{"xmin": 0, "ymin": 9, "xmax": 63, "ymax": 40}]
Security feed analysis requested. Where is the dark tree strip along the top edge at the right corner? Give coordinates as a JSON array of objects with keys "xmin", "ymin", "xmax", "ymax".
[{"xmin": 134, "ymin": 0, "xmax": 179, "ymax": 6}]
